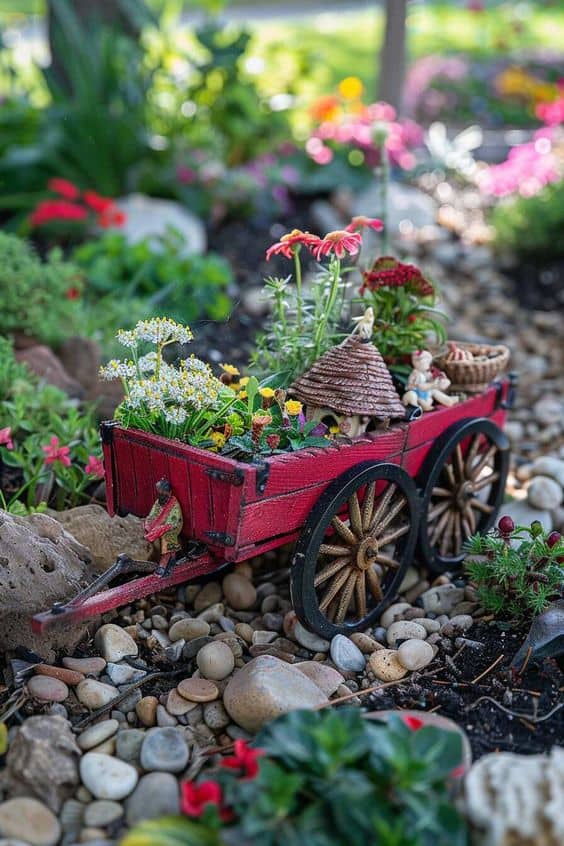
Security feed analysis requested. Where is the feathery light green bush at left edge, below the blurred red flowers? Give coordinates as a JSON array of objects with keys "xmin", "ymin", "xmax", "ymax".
[{"xmin": 0, "ymin": 232, "xmax": 81, "ymax": 344}]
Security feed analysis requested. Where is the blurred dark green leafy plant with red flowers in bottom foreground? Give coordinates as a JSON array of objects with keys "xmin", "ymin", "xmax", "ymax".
[{"xmin": 122, "ymin": 709, "xmax": 468, "ymax": 846}]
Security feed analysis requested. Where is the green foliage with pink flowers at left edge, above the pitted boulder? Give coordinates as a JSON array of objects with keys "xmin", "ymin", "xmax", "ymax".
[{"xmin": 0, "ymin": 338, "xmax": 100, "ymax": 514}]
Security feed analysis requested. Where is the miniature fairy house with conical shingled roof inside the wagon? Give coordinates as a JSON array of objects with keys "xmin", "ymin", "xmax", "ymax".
[{"xmin": 289, "ymin": 335, "xmax": 405, "ymax": 437}]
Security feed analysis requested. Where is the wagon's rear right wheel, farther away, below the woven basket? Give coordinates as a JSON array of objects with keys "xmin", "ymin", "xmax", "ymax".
[{"xmin": 419, "ymin": 419, "xmax": 509, "ymax": 573}]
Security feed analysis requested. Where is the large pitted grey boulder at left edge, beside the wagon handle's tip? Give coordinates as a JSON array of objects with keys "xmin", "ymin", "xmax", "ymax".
[{"xmin": 0, "ymin": 511, "xmax": 96, "ymax": 658}]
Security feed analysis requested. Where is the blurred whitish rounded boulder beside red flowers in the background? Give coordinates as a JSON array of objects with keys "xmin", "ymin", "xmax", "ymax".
[{"xmin": 117, "ymin": 194, "xmax": 207, "ymax": 255}]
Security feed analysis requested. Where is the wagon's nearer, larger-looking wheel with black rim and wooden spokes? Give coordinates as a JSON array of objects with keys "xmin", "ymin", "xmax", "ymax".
[{"xmin": 291, "ymin": 462, "xmax": 419, "ymax": 638}]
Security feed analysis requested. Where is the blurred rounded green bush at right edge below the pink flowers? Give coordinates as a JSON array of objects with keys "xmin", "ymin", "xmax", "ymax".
[{"xmin": 491, "ymin": 180, "xmax": 564, "ymax": 262}]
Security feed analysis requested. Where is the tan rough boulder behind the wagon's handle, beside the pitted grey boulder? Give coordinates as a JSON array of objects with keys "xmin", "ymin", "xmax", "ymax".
[{"xmin": 52, "ymin": 505, "xmax": 153, "ymax": 572}]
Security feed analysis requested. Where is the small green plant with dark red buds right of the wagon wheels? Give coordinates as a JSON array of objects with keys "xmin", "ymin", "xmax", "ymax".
[{"xmin": 464, "ymin": 516, "xmax": 564, "ymax": 622}]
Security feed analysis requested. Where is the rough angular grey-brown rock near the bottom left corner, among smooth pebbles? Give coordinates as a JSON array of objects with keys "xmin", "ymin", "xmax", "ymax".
[{"xmin": 4, "ymin": 715, "xmax": 80, "ymax": 813}]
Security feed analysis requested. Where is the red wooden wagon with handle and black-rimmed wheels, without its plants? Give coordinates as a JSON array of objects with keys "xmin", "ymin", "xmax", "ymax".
[{"xmin": 29, "ymin": 377, "xmax": 513, "ymax": 637}]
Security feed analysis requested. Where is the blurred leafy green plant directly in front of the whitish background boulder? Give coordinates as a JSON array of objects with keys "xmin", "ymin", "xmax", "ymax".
[{"xmin": 72, "ymin": 231, "xmax": 233, "ymax": 322}]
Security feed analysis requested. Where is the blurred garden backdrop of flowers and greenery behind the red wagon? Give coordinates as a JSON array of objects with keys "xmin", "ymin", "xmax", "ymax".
[{"xmin": 0, "ymin": 0, "xmax": 564, "ymax": 508}]
